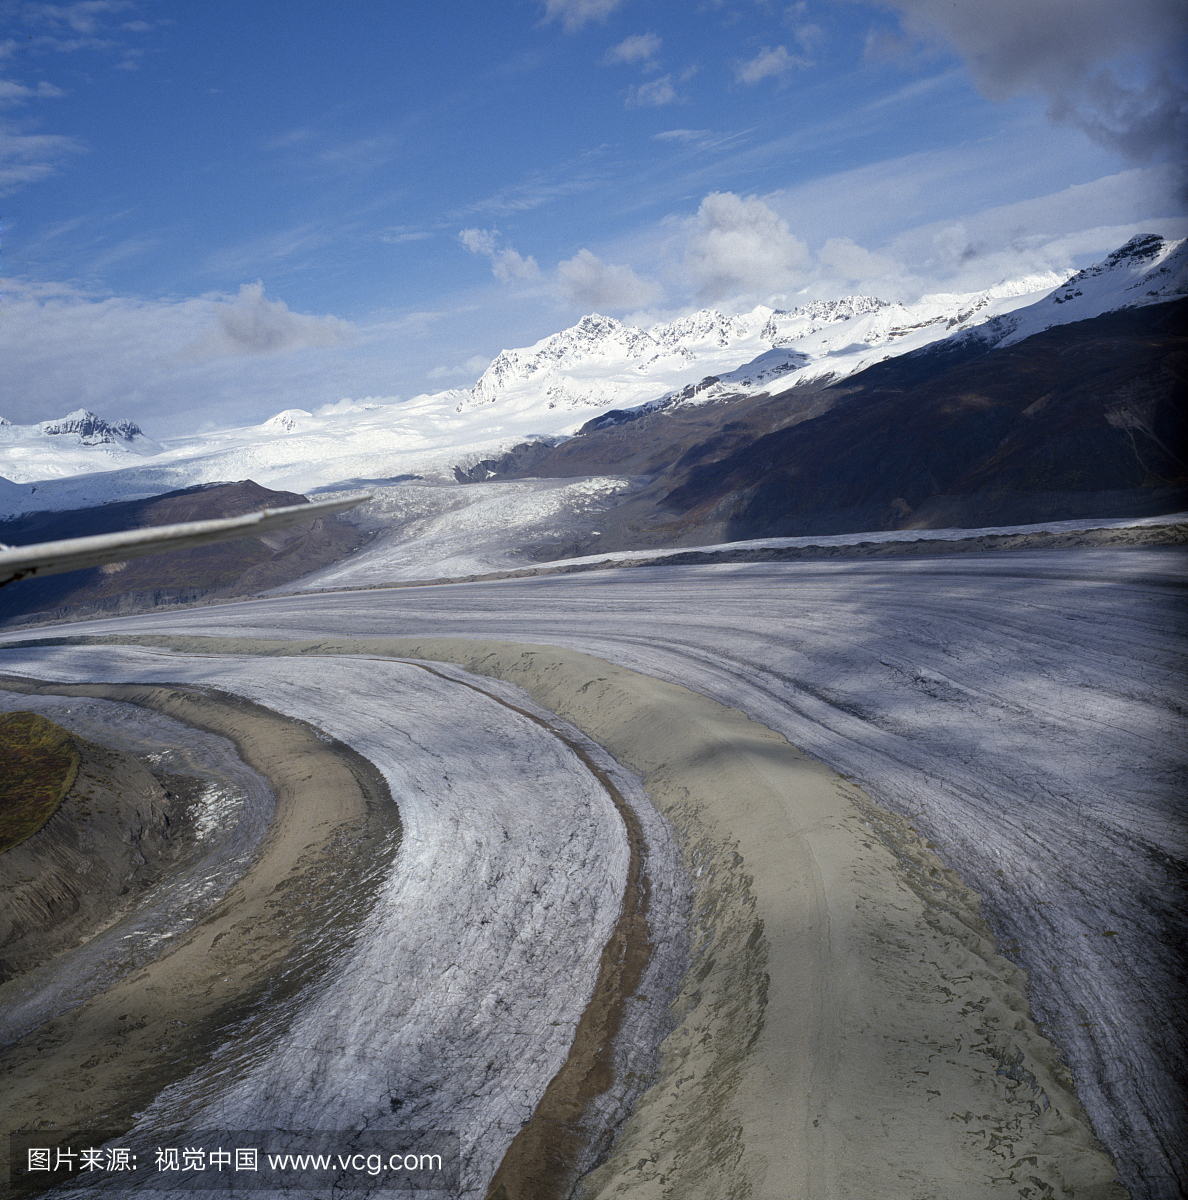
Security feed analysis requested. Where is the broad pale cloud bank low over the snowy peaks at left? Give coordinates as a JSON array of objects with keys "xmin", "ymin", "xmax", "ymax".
[{"xmin": 0, "ymin": 280, "xmax": 374, "ymax": 437}]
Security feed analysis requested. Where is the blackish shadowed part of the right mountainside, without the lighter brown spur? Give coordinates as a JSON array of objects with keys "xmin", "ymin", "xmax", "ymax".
[{"xmin": 665, "ymin": 295, "xmax": 1188, "ymax": 540}]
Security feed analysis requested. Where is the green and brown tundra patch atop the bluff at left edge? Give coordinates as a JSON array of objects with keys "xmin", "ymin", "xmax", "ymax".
[{"xmin": 0, "ymin": 713, "xmax": 78, "ymax": 853}]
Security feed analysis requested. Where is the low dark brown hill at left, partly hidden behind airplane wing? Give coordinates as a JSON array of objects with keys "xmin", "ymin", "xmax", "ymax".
[{"xmin": 0, "ymin": 480, "xmax": 364, "ymax": 626}]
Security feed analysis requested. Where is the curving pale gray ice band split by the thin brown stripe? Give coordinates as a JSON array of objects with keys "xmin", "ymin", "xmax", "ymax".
[{"xmin": 2, "ymin": 647, "xmax": 683, "ymax": 1196}]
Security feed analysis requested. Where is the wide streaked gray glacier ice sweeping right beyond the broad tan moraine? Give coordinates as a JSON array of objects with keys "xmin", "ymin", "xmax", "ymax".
[{"xmin": 0, "ymin": 548, "xmax": 1188, "ymax": 1198}]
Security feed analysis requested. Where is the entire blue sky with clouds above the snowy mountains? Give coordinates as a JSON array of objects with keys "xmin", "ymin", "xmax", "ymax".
[{"xmin": 0, "ymin": 0, "xmax": 1186, "ymax": 436}]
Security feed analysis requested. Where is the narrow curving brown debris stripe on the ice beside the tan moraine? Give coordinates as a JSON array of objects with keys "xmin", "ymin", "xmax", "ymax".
[{"xmin": 406, "ymin": 660, "xmax": 653, "ymax": 1200}]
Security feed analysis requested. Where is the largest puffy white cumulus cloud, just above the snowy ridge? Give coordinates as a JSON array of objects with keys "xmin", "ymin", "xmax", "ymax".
[{"xmin": 685, "ymin": 192, "xmax": 810, "ymax": 300}]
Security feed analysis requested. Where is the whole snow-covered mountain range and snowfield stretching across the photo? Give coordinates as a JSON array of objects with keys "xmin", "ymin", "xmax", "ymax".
[{"xmin": 0, "ymin": 235, "xmax": 1188, "ymax": 515}]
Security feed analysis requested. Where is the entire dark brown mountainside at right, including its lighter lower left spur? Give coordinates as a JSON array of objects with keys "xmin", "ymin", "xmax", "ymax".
[{"xmin": 472, "ymin": 300, "xmax": 1188, "ymax": 550}]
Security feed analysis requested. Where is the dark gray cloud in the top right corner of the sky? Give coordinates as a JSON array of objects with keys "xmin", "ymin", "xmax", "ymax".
[{"xmin": 871, "ymin": 0, "xmax": 1188, "ymax": 161}]
